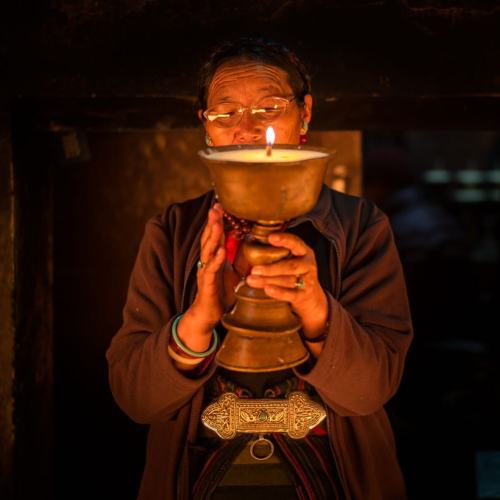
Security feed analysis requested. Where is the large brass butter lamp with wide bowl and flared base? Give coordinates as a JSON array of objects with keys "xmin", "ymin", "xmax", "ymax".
[{"xmin": 198, "ymin": 139, "xmax": 330, "ymax": 372}]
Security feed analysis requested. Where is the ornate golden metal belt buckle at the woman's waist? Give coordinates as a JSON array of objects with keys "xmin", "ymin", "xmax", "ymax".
[{"xmin": 201, "ymin": 392, "xmax": 326, "ymax": 439}]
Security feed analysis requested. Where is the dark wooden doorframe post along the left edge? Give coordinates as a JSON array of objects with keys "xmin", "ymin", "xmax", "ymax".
[{"xmin": 0, "ymin": 103, "xmax": 54, "ymax": 500}]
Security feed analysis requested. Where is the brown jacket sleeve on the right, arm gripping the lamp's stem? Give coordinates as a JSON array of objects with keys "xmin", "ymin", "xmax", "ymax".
[{"xmin": 297, "ymin": 210, "xmax": 413, "ymax": 416}]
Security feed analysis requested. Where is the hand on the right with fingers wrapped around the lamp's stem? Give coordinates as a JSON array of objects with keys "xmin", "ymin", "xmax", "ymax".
[{"xmin": 246, "ymin": 233, "xmax": 328, "ymax": 338}]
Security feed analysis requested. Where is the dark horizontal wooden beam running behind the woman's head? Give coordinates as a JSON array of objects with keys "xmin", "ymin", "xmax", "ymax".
[{"xmin": 27, "ymin": 94, "xmax": 500, "ymax": 133}]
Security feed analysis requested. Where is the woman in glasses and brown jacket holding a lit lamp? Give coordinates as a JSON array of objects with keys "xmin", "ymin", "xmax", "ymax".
[{"xmin": 107, "ymin": 40, "xmax": 412, "ymax": 500}]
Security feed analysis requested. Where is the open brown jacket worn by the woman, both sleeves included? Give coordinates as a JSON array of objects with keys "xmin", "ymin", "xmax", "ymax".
[{"xmin": 107, "ymin": 186, "xmax": 412, "ymax": 500}]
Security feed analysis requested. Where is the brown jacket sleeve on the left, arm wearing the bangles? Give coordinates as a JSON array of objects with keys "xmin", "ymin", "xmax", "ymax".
[{"xmin": 106, "ymin": 210, "xmax": 214, "ymax": 424}]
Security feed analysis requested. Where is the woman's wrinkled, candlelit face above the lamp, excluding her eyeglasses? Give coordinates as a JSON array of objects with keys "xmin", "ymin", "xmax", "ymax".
[{"xmin": 200, "ymin": 62, "xmax": 312, "ymax": 146}]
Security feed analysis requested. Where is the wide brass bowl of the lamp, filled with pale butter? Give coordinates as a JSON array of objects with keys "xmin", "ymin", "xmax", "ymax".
[{"xmin": 198, "ymin": 144, "xmax": 331, "ymax": 221}]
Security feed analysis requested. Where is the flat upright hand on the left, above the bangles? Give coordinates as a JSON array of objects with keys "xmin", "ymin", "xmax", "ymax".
[{"xmin": 177, "ymin": 203, "xmax": 226, "ymax": 352}]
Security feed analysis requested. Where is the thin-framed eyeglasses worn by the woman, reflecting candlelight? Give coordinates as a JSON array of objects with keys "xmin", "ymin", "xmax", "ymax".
[{"xmin": 203, "ymin": 96, "xmax": 295, "ymax": 128}]
